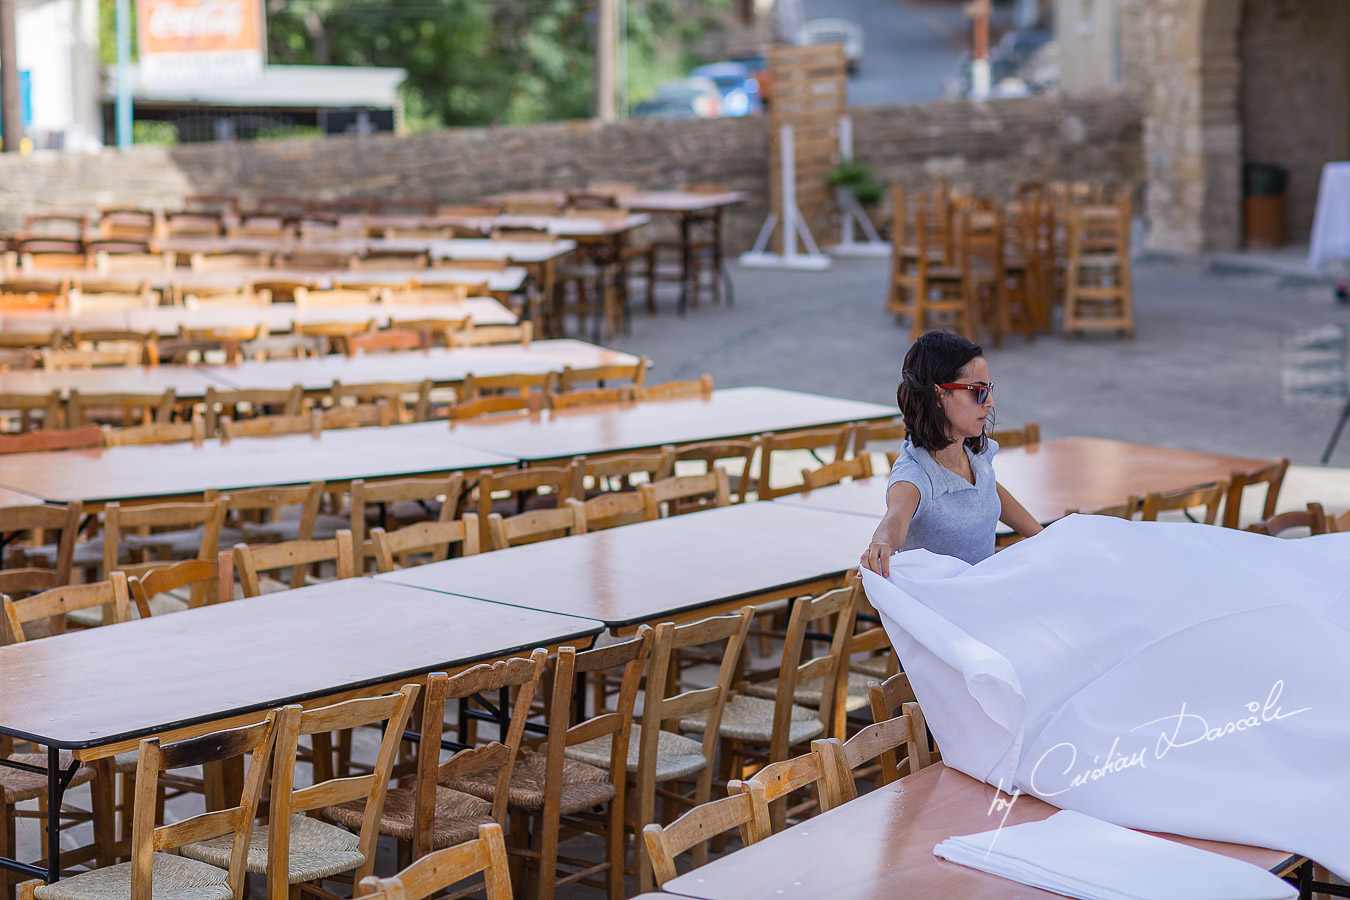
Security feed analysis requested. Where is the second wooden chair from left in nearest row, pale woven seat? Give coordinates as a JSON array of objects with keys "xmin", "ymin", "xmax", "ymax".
[{"xmin": 181, "ymin": 684, "xmax": 419, "ymax": 900}]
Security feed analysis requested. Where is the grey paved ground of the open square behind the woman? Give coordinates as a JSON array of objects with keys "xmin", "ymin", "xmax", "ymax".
[{"xmin": 614, "ymin": 249, "xmax": 1350, "ymax": 510}]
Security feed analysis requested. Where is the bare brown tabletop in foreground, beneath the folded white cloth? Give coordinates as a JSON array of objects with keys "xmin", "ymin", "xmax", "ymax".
[{"xmin": 662, "ymin": 762, "xmax": 1303, "ymax": 900}]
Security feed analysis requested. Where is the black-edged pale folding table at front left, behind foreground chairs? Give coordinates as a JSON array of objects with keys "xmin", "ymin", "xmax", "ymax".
[{"xmin": 0, "ymin": 579, "xmax": 601, "ymax": 881}]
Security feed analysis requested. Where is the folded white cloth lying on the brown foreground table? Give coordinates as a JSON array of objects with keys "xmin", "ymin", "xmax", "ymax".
[{"xmin": 933, "ymin": 810, "xmax": 1299, "ymax": 900}]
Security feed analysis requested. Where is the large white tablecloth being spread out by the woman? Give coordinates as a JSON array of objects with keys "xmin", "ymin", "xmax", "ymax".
[{"xmin": 863, "ymin": 515, "xmax": 1350, "ymax": 877}]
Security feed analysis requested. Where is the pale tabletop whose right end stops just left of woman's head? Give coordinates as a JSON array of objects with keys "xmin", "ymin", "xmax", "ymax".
[{"xmin": 442, "ymin": 387, "xmax": 894, "ymax": 464}]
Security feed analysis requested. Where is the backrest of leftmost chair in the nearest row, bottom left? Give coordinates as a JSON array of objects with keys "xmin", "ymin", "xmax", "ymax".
[{"xmin": 131, "ymin": 711, "xmax": 277, "ymax": 900}]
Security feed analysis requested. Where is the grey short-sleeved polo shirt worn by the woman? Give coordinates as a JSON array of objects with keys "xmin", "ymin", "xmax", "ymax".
[{"xmin": 886, "ymin": 441, "xmax": 1002, "ymax": 565}]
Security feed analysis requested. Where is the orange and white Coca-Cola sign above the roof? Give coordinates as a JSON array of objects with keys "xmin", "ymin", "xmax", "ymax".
[{"xmin": 136, "ymin": 0, "xmax": 263, "ymax": 88}]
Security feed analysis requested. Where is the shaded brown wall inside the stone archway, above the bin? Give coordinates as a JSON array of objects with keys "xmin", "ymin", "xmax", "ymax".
[{"xmin": 1241, "ymin": 0, "xmax": 1350, "ymax": 242}]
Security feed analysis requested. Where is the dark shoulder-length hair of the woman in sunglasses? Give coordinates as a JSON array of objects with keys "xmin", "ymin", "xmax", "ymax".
[{"xmin": 895, "ymin": 331, "xmax": 988, "ymax": 453}]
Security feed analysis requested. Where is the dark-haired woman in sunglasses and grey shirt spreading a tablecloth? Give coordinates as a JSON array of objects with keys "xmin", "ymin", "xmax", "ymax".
[{"xmin": 861, "ymin": 331, "xmax": 1041, "ymax": 578}]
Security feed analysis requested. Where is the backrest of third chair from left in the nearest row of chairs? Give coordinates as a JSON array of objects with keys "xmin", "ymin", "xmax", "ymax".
[{"xmin": 413, "ymin": 649, "xmax": 548, "ymax": 858}]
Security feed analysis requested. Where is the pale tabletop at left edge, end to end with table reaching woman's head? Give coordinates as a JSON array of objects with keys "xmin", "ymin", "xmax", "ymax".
[{"xmin": 0, "ymin": 422, "xmax": 517, "ymax": 511}]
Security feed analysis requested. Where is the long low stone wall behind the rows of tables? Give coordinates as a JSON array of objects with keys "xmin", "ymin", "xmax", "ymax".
[{"xmin": 0, "ymin": 94, "xmax": 1143, "ymax": 250}]
